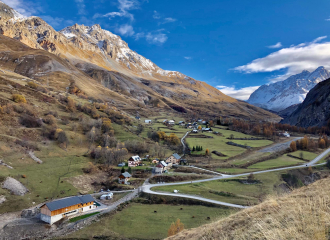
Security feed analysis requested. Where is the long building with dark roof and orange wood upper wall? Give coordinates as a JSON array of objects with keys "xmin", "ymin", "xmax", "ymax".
[{"xmin": 40, "ymin": 195, "xmax": 96, "ymax": 225}]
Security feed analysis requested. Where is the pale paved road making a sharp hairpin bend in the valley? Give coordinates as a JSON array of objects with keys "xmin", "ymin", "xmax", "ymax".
[{"xmin": 141, "ymin": 148, "xmax": 330, "ymax": 208}]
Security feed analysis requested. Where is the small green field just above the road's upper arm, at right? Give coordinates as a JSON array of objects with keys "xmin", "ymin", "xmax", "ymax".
[{"xmin": 248, "ymin": 155, "xmax": 305, "ymax": 170}]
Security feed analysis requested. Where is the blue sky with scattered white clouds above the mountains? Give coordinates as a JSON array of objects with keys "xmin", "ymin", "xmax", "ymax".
[{"xmin": 2, "ymin": 0, "xmax": 330, "ymax": 100}]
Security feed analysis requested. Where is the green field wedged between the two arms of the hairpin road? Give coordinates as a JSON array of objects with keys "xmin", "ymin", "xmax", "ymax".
[{"xmin": 152, "ymin": 171, "xmax": 283, "ymax": 205}]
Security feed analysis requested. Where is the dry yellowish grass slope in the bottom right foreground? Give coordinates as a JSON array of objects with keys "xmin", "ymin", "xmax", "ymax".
[{"xmin": 168, "ymin": 178, "xmax": 330, "ymax": 240}]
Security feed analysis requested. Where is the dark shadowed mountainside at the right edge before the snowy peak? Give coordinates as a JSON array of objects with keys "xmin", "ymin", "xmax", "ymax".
[{"xmin": 282, "ymin": 79, "xmax": 330, "ymax": 127}]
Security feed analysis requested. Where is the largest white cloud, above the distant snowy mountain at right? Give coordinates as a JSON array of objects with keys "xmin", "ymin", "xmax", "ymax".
[{"xmin": 234, "ymin": 36, "xmax": 330, "ymax": 82}]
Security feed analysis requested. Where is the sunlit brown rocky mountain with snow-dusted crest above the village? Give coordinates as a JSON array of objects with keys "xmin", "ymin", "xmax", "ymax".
[{"xmin": 0, "ymin": 2, "xmax": 278, "ymax": 120}]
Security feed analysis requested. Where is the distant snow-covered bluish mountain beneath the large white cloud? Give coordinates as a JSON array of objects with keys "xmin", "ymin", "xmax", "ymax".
[{"xmin": 247, "ymin": 67, "xmax": 330, "ymax": 112}]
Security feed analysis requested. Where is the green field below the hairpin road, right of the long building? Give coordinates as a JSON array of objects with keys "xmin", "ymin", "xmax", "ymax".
[{"xmin": 66, "ymin": 203, "xmax": 237, "ymax": 239}]
